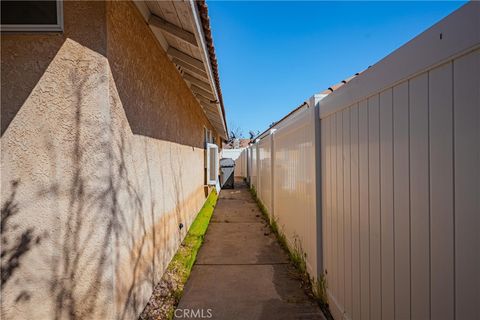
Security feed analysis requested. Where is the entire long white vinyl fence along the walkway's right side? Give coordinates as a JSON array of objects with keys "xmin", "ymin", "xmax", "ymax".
[{"xmin": 238, "ymin": 2, "xmax": 480, "ymax": 319}]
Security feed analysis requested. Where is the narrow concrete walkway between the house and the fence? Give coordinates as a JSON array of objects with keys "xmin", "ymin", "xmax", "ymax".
[{"xmin": 175, "ymin": 181, "xmax": 325, "ymax": 320}]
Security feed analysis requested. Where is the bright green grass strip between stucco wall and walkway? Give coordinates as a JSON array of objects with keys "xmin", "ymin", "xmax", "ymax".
[{"xmin": 139, "ymin": 190, "xmax": 218, "ymax": 320}]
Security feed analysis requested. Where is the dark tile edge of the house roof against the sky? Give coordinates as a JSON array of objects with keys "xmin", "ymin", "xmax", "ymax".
[{"xmin": 195, "ymin": 0, "xmax": 228, "ymax": 137}]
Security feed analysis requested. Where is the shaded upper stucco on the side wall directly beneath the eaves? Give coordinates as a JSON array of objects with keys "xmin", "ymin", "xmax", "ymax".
[{"xmin": 107, "ymin": 1, "xmax": 213, "ymax": 148}]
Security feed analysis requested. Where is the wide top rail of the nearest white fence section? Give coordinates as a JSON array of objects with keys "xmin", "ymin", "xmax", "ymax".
[{"xmin": 320, "ymin": 1, "xmax": 480, "ymax": 118}]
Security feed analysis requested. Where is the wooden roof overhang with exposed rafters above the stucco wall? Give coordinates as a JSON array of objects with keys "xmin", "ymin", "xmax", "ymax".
[{"xmin": 134, "ymin": 0, "xmax": 228, "ymax": 138}]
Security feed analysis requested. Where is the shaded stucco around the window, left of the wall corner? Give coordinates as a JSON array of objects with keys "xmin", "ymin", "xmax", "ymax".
[{"xmin": 1, "ymin": 1, "xmax": 107, "ymax": 135}]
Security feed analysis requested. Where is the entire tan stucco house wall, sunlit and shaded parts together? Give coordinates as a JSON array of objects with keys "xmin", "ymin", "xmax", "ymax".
[{"xmin": 1, "ymin": 1, "xmax": 218, "ymax": 319}]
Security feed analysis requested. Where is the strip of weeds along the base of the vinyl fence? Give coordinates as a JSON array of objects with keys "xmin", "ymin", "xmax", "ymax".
[{"xmin": 250, "ymin": 186, "xmax": 333, "ymax": 320}]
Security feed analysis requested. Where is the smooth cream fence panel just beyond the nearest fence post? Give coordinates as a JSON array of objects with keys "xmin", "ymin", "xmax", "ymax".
[{"xmin": 272, "ymin": 108, "xmax": 321, "ymax": 278}]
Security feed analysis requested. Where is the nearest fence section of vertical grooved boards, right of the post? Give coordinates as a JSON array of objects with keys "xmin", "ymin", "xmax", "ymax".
[{"xmin": 320, "ymin": 11, "xmax": 480, "ymax": 319}]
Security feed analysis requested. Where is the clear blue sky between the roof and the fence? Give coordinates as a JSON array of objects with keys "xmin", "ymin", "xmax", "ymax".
[{"xmin": 208, "ymin": 1, "xmax": 465, "ymax": 136}]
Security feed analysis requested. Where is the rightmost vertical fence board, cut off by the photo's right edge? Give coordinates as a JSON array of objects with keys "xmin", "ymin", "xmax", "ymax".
[{"xmin": 453, "ymin": 50, "xmax": 480, "ymax": 319}]
